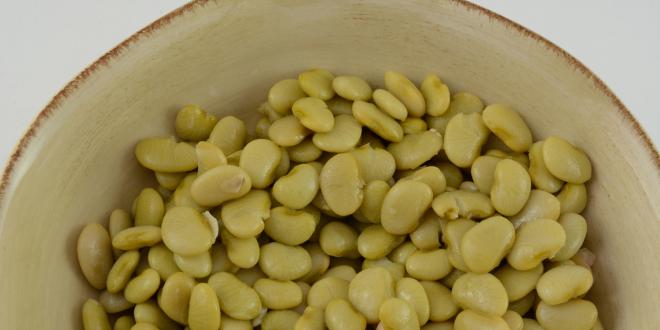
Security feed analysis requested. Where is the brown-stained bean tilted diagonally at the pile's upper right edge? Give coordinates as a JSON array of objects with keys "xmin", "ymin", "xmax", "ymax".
[{"xmin": 483, "ymin": 104, "xmax": 532, "ymax": 152}]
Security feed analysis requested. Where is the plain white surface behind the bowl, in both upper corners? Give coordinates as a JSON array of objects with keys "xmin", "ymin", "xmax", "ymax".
[{"xmin": 0, "ymin": 0, "xmax": 660, "ymax": 166}]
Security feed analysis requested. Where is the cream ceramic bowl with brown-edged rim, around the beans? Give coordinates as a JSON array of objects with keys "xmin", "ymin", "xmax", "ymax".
[{"xmin": 0, "ymin": 0, "xmax": 660, "ymax": 329}]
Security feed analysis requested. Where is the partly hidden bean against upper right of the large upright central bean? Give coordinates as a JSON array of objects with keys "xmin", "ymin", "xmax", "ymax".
[{"xmin": 350, "ymin": 144, "xmax": 396, "ymax": 183}]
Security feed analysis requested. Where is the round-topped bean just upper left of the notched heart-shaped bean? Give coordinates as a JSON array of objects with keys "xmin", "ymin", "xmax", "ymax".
[{"xmin": 239, "ymin": 139, "xmax": 282, "ymax": 189}]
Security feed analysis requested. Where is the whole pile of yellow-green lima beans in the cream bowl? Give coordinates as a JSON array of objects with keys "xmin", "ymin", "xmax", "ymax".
[{"xmin": 77, "ymin": 69, "xmax": 602, "ymax": 330}]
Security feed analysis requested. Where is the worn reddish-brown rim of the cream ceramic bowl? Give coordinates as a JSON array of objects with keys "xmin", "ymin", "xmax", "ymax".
[{"xmin": 0, "ymin": 0, "xmax": 660, "ymax": 206}]
